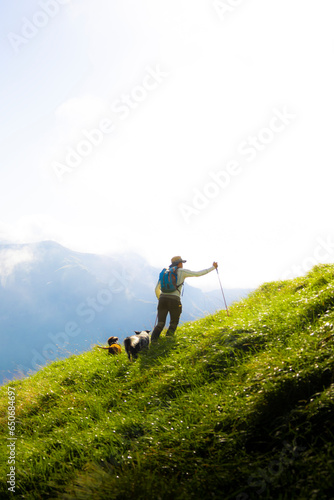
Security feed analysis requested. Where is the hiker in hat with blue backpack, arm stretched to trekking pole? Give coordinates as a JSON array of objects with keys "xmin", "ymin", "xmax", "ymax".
[{"xmin": 151, "ymin": 255, "xmax": 218, "ymax": 342}]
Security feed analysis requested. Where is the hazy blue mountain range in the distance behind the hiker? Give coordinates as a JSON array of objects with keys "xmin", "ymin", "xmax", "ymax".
[{"xmin": 0, "ymin": 241, "xmax": 249, "ymax": 383}]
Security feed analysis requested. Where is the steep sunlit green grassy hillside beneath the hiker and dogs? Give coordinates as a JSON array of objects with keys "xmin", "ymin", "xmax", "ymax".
[{"xmin": 0, "ymin": 265, "xmax": 334, "ymax": 500}]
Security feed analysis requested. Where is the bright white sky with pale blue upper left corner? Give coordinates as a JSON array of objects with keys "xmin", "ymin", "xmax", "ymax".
[{"xmin": 0, "ymin": 0, "xmax": 334, "ymax": 289}]
